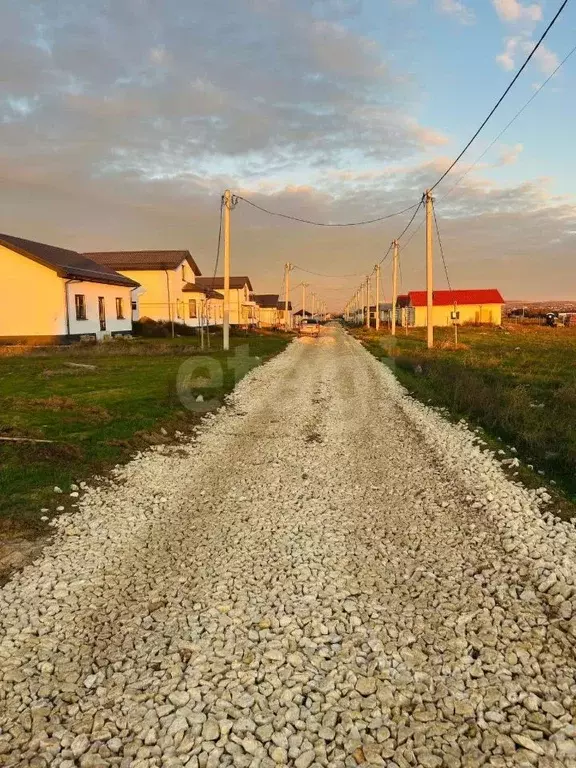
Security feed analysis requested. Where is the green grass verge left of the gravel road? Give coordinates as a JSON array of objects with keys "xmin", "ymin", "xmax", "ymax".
[{"xmin": 0, "ymin": 333, "xmax": 291, "ymax": 531}]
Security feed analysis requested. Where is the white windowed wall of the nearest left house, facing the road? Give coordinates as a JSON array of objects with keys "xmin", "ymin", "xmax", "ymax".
[{"xmin": 68, "ymin": 281, "xmax": 132, "ymax": 339}]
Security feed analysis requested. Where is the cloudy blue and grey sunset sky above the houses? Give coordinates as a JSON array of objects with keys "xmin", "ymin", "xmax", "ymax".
[{"xmin": 0, "ymin": 0, "xmax": 576, "ymax": 310}]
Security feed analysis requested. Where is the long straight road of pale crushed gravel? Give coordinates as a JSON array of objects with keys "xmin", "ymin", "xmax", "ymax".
[{"xmin": 0, "ymin": 328, "xmax": 576, "ymax": 768}]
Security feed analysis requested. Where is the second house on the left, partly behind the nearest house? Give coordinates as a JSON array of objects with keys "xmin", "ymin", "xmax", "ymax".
[{"xmin": 84, "ymin": 250, "xmax": 201, "ymax": 327}]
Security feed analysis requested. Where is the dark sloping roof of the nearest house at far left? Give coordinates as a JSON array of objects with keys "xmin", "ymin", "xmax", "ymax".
[{"xmin": 0, "ymin": 234, "xmax": 139, "ymax": 288}]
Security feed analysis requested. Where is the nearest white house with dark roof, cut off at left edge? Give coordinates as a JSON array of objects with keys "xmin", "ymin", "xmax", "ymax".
[{"xmin": 0, "ymin": 234, "xmax": 138, "ymax": 344}]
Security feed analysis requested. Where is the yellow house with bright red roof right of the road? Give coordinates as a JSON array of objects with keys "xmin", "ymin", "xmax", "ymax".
[{"xmin": 408, "ymin": 288, "xmax": 504, "ymax": 328}]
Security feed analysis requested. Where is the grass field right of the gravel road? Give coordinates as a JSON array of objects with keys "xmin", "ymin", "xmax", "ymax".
[{"xmin": 352, "ymin": 325, "xmax": 576, "ymax": 499}]
